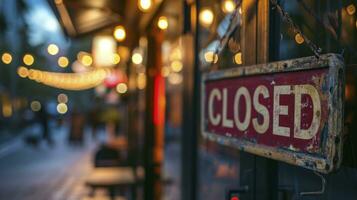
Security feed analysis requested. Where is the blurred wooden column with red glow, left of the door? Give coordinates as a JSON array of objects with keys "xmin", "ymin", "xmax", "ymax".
[{"xmin": 144, "ymin": 30, "xmax": 165, "ymax": 200}]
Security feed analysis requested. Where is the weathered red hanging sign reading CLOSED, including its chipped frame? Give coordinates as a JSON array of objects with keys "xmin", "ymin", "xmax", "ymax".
[{"xmin": 201, "ymin": 54, "xmax": 344, "ymax": 173}]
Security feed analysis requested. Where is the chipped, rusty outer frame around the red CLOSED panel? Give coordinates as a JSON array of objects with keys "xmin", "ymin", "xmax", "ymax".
[{"xmin": 200, "ymin": 53, "xmax": 345, "ymax": 174}]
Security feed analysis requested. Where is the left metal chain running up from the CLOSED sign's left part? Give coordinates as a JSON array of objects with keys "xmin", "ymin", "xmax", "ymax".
[{"xmin": 210, "ymin": 0, "xmax": 242, "ymax": 70}]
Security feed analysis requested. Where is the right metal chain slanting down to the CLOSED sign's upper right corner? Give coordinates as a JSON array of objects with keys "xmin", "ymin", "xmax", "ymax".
[{"xmin": 270, "ymin": 0, "xmax": 322, "ymax": 58}]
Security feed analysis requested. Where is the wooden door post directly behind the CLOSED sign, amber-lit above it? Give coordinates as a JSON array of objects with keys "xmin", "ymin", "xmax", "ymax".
[{"xmin": 240, "ymin": 0, "xmax": 278, "ymax": 200}]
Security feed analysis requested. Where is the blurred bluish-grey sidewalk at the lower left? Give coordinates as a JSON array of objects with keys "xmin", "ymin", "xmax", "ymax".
[{"xmin": 0, "ymin": 123, "xmax": 123, "ymax": 200}]
